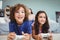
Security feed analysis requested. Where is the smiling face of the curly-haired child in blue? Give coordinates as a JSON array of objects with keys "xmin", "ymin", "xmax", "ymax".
[{"xmin": 15, "ymin": 7, "xmax": 25, "ymax": 24}]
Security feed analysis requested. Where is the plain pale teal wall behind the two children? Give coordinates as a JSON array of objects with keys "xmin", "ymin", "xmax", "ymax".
[{"xmin": 2, "ymin": 0, "xmax": 60, "ymax": 21}]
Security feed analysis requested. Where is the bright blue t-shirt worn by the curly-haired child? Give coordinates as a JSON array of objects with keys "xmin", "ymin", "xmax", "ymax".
[{"xmin": 9, "ymin": 20, "xmax": 32, "ymax": 35}]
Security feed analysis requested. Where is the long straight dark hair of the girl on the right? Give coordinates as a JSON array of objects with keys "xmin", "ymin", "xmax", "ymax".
[{"xmin": 34, "ymin": 11, "xmax": 49, "ymax": 35}]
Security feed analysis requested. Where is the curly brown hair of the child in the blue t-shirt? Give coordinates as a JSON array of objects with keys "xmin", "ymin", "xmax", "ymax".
[{"xmin": 10, "ymin": 4, "xmax": 28, "ymax": 22}]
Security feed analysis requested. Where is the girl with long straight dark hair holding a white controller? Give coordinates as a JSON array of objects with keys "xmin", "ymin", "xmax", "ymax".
[{"xmin": 32, "ymin": 11, "xmax": 52, "ymax": 40}]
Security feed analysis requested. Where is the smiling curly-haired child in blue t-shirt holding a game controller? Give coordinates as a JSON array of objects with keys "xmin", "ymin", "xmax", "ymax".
[{"xmin": 8, "ymin": 4, "xmax": 32, "ymax": 40}]
